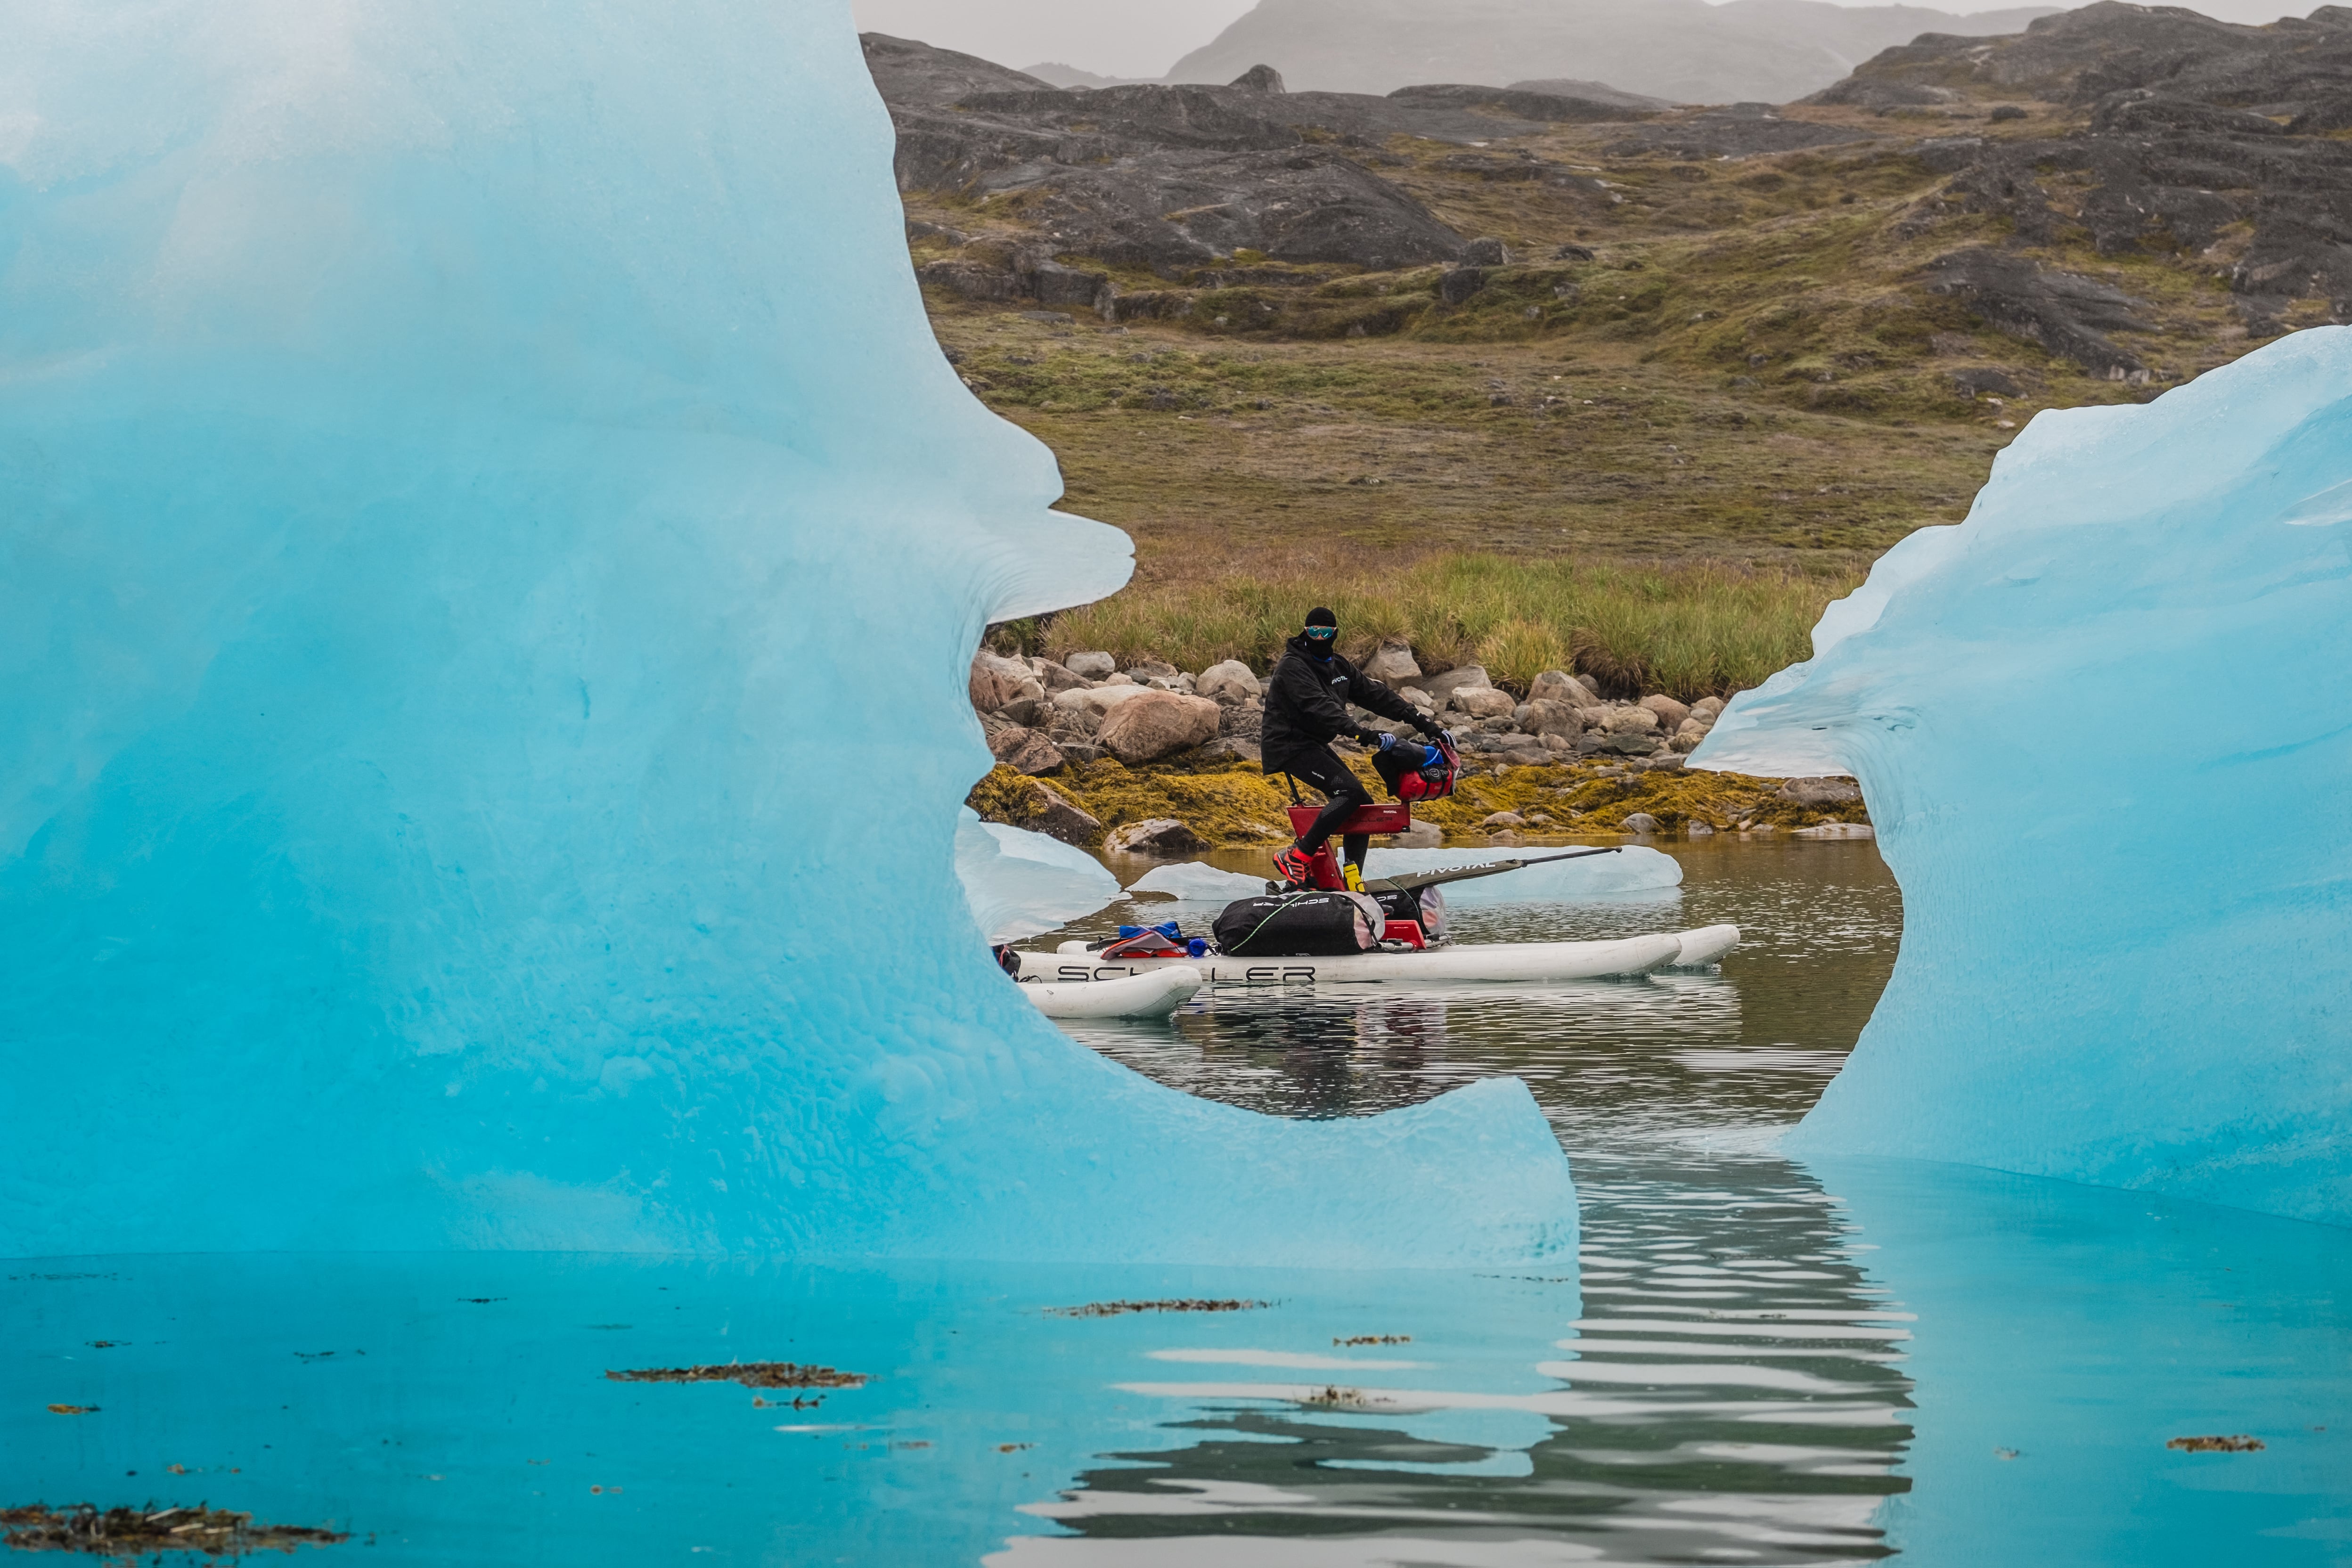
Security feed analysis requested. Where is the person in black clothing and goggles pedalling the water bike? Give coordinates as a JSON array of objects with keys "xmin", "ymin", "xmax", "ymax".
[{"xmin": 1258, "ymin": 609, "xmax": 1446, "ymax": 889}]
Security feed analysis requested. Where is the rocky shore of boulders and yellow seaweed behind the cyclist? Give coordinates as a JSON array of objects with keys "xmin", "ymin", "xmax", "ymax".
[{"xmin": 972, "ymin": 642, "xmax": 1870, "ymax": 856}]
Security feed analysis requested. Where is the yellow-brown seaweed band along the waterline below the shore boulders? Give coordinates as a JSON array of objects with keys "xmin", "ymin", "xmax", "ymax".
[{"xmin": 969, "ymin": 757, "xmax": 1870, "ymax": 849}]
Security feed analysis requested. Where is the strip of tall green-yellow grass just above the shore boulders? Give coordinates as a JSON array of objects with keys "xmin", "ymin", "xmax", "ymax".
[{"xmin": 1004, "ymin": 555, "xmax": 1858, "ymax": 701}]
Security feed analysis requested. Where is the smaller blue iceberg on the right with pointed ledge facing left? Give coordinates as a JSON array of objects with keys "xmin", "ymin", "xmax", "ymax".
[{"xmin": 1691, "ymin": 327, "xmax": 2352, "ymax": 1225}]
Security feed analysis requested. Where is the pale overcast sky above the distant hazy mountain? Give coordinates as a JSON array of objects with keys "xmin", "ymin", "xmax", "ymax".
[{"xmin": 854, "ymin": 0, "xmax": 2317, "ymax": 80}]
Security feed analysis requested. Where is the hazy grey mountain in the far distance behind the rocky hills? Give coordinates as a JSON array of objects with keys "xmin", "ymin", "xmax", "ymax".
[{"xmin": 1169, "ymin": 0, "xmax": 2053, "ymax": 104}]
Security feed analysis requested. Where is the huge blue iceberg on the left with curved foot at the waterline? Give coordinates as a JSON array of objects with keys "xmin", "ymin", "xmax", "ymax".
[{"xmin": 0, "ymin": 0, "xmax": 1576, "ymax": 1265}]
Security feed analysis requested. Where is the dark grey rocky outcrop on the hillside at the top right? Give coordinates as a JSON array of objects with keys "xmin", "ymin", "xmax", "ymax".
[{"xmin": 1818, "ymin": 0, "xmax": 2352, "ymax": 336}]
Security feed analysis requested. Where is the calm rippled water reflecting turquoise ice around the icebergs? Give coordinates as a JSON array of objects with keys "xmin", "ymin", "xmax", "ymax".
[{"xmin": 0, "ymin": 841, "xmax": 2352, "ymax": 1568}]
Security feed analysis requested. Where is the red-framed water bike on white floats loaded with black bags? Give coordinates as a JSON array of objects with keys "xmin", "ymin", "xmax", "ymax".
[{"xmin": 1004, "ymin": 743, "xmax": 1740, "ymax": 988}]
